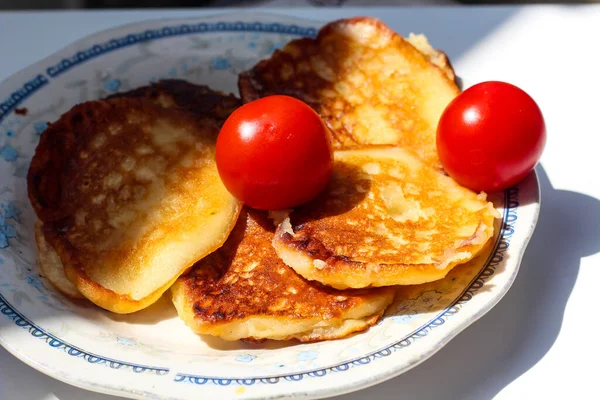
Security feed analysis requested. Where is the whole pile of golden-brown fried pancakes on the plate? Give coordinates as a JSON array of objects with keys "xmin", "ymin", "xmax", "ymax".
[{"xmin": 28, "ymin": 18, "xmax": 497, "ymax": 341}]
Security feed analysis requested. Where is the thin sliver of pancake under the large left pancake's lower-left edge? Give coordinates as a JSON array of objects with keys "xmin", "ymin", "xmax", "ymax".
[{"xmin": 34, "ymin": 220, "xmax": 85, "ymax": 299}]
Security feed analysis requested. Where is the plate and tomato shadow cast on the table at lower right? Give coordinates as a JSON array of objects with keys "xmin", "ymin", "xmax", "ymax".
[{"xmin": 336, "ymin": 166, "xmax": 600, "ymax": 400}]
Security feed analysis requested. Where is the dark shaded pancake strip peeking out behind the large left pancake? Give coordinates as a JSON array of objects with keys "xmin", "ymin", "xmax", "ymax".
[{"xmin": 109, "ymin": 79, "xmax": 242, "ymax": 125}]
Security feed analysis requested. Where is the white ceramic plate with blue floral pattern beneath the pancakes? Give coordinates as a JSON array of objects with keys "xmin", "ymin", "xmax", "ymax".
[{"xmin": 0, "ymin": 14, "xmax": 539, "ymax": 399}]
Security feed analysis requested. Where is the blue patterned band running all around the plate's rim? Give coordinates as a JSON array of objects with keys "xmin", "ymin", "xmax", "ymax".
[{"xmin": 0, "ymin": 18, "xmax": 519, "ymax": 386}]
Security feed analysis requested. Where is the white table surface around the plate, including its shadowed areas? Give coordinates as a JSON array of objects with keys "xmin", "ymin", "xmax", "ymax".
[{"xmin": 0, "ymin": 6, "xmax": 600, "ymax": 400}]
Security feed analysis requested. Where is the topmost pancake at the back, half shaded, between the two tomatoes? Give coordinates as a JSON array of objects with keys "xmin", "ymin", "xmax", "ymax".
[{"xmin": 238, "ymin": 17, "xmax": 459, "ymax": 168}]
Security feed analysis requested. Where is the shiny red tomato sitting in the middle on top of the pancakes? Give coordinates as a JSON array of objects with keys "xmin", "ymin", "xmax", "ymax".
[{"xmin": 216, "ymin": 96, "xmax": 333, "ymax": 210}]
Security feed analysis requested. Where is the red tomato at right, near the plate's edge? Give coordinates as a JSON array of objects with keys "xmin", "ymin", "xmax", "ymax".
[{"xmin": 437, "ymin": 82, "xmax": 546, "ymax": 191}]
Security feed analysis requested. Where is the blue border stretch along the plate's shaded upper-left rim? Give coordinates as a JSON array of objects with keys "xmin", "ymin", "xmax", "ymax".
[{"xmin": 0, "ymin": 21, "xmax": 317, "ymax": 123}]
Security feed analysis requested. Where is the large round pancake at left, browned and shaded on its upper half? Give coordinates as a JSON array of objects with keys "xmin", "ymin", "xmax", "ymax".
[{"xmin": 27, "ymin": 99, "xmax": 241, "ymax": 313}]
